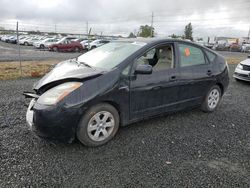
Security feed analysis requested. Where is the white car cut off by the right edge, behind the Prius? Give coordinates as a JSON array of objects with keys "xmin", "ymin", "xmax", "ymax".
[{"xmin": 233, "ymin": 55, "xmax": 250, "ymax": 82}]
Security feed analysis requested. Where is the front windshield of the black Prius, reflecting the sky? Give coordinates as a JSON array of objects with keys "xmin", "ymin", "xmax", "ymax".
[{"xmin": 78, "ymin": 42, "xmax": 146, "ymax": 70}]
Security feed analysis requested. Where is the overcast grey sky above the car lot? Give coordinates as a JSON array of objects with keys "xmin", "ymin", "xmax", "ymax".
[{"xmin": 0, "ymin": 0, "xmax": 250, "ymax": 37}]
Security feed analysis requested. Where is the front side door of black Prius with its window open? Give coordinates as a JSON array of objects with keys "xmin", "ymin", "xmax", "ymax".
[{"xmin": 130, "ymin": 43, "xmax": 179, "ymax": 120}]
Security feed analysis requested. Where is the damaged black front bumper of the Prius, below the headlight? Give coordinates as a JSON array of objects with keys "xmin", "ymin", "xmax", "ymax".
[{"xmin": 24, "ymin": 94, "xmax": 81, "ymax": 142}]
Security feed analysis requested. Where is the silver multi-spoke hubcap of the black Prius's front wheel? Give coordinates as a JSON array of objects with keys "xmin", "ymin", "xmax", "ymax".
[{"xmin": 87, "ymin": 111, "xmax": 115, "ymax": 141}]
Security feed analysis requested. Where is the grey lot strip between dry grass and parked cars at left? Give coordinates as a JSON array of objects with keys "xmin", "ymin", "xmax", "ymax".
[{"xmin": 0, "ymin": 41, "xmax": 80, "ymax": 62}]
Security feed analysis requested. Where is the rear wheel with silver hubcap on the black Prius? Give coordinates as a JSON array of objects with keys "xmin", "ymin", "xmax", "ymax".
[{"xmin": 201, "ymin": 85, "xmax": 221, "ymax": 112}]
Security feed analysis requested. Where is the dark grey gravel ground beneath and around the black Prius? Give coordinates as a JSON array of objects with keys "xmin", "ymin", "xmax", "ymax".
[{"xmin": 0, "ymin": 65, "xmax": 250, "ymax": 188}]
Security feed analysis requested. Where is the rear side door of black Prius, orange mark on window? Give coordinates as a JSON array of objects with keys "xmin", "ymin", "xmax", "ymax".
[{"xmin": 178, "ymin": 42, "xmax": 215, "ymax": 106}]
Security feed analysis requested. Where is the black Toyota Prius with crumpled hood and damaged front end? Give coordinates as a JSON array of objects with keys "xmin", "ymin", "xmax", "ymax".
[{"xmin": 24, "ymin": 39, "xmax": 229, "ymax": 146}]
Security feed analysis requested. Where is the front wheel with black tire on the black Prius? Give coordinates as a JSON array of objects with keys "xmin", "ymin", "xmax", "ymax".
[{"xmin": 76, "ymin": 103, "xmax": 120, "ymax": 147}]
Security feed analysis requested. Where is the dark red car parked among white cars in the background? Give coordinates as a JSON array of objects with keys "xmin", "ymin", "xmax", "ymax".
[{"xmin": 49, "ymin": 38, "xmax": 84, "ymax": 52}]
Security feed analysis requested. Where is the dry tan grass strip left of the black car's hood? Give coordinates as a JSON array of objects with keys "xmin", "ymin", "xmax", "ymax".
[{"xmin": 0, "ymin": 60, "xmax": 59, "ymax": 80}]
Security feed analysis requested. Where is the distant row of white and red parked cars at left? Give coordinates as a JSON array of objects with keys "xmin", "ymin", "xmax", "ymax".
[{"xmin": 0, "ymin": 35, "xmax": 110, "ymax": 52}]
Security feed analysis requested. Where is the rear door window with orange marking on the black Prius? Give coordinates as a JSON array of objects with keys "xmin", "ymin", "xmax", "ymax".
[{"xmin": 178, "ymin": 44, "xmax": 206, "ymax": 67}]
